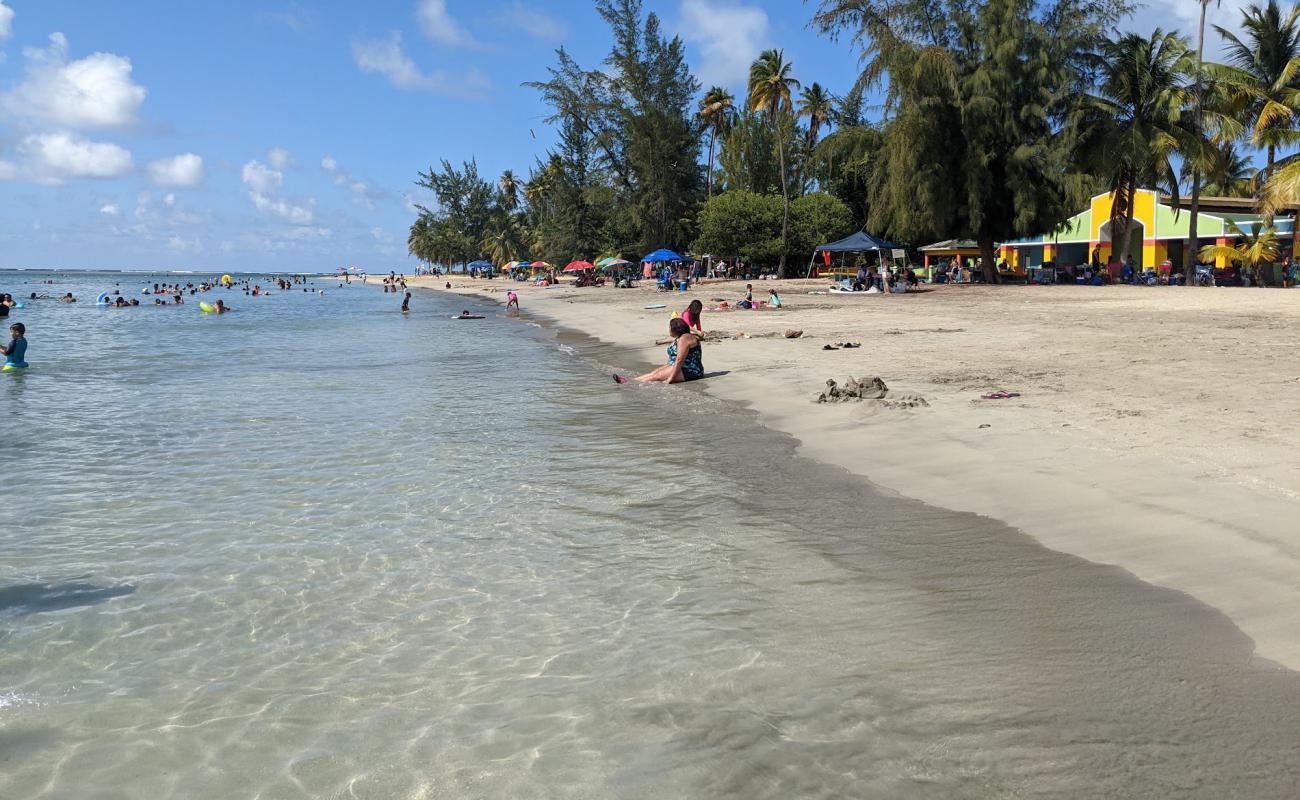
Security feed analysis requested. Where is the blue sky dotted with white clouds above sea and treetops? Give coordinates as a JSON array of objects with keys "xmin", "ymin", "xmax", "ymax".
[{"xmin": 0, "ymin": 0, "xmax": 1258, "ymax": 272}]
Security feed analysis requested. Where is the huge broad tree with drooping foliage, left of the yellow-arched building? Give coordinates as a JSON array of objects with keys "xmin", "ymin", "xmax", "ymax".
[{"xmin": 814, "ymin": 0, "xmax": 1128, "ymax": 280}]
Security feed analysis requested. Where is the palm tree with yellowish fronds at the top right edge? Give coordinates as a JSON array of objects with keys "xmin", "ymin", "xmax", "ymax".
[{"xmin": 1213, "ymin": 0, "xmax": 1300, "ymax": 181}]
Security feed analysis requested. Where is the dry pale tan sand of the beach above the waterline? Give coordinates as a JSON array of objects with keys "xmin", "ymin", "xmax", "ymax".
[{"xmin": 395, "ymin": 278, "xmax": 1300, "ymax": 669}]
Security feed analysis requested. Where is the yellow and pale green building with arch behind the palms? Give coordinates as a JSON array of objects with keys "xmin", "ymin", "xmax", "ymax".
[{"xmin": 998, "ymin": 189, "xmax": 1300, "ymax": 272}]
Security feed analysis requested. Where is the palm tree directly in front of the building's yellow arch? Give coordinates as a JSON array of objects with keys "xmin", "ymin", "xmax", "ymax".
[{"xmin": 1079, "ymin": 27, "xmax": 1195, "ymax": 266}]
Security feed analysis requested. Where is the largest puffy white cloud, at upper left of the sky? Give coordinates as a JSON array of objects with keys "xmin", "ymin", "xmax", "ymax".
[{"xmin": 0, "ymin": 33, "xmax": 148, "ymax": 129}]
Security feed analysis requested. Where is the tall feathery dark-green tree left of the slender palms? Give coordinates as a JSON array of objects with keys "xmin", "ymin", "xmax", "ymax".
[{"xmin": 525, "ymin": 0, "xmax": 702, "ymax": 260}]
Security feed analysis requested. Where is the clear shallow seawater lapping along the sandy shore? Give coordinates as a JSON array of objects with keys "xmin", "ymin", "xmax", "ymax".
[{"xmin": 0, "ymin": 273, "xmax": 1300, "ymax": 800}]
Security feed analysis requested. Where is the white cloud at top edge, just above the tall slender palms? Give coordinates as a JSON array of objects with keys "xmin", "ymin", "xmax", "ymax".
[{"xmin": 680, "ymin": 0, "xmax": 768, "ymax": 86}]
